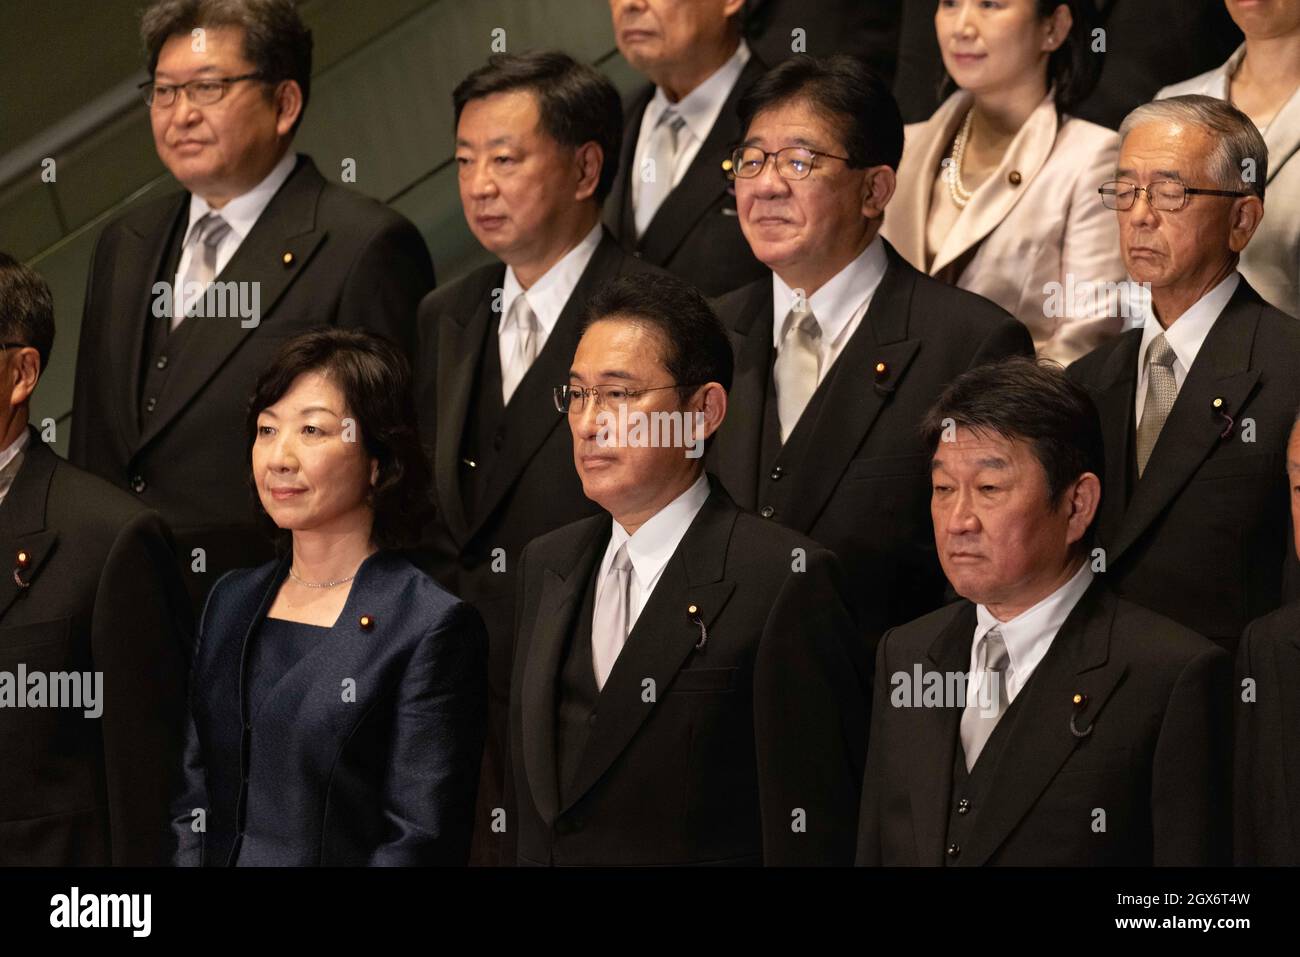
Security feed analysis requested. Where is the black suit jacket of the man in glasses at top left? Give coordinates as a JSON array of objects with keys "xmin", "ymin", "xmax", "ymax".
[{"xmin": 69, "ymin": 156, "xmax": 433, "ymax": 607}]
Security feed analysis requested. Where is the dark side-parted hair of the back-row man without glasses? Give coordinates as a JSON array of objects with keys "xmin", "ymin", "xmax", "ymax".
[{"xmin": 451, "ymin": 49, "xmax": 623, "ymax": 203}]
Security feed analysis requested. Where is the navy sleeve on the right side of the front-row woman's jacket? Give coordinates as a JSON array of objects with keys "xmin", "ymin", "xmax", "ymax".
[{"xmin": 369, "ymin": 602, "xmax": 488, "ymax": 866}]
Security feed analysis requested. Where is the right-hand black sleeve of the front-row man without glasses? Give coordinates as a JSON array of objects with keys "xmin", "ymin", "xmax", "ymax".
[{"xmin": 1151, "ymin": 646, "xmax": 1232, "ymax": 866}]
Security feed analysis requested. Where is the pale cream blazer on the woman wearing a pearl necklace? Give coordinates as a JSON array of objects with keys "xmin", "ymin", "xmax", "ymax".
[{"xmin": 883, "ymin": 90, "xmax": 1127, "ymax": 365}]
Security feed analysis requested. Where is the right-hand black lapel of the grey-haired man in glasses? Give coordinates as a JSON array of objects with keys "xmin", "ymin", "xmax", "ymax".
[{"xmin": 1106, "ymin": 287, "xmax": 1260, "ymax": 563}]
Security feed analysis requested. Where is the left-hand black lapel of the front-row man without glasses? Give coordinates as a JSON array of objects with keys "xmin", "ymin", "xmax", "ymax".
[{"xmin": 907, "ymin": 602, "xmax": 975, "ymax": 865}]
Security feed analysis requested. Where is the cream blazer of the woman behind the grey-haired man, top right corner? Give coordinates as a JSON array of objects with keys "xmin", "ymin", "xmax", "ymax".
[{"xmin": 1156, "ymin": 44, "xmax": 1300, "ymax": 317}]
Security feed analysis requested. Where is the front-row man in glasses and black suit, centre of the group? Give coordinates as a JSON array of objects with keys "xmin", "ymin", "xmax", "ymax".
[{"xmin": 507, "ymin": 276, "xmax": 866, "ymax": 865}]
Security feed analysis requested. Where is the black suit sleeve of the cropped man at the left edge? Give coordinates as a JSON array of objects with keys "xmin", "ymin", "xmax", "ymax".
[{"xmin": 91, "ymin": 512, "xmax": 194, "ymax": 866}]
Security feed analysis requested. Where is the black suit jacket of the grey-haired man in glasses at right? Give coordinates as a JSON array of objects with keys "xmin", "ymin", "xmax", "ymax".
[{"xmin": 1067, "ymin": 280, "xmax": 1300, "ymax": 651}]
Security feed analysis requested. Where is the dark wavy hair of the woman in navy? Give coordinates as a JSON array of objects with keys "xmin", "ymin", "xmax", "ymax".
[{"xmin": 247, "ymin": 329, "xmax": 433, "ymax": 549}]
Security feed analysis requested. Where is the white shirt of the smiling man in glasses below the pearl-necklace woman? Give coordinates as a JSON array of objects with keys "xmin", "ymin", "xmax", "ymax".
[{"xmin": 772, "ymin": 234, "xmax": 889, "ymax": 385}]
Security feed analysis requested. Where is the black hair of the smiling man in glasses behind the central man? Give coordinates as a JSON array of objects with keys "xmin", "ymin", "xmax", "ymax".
[{"xmin": 737, "ymin": 53, "xmax": 902, "ymax": 169}]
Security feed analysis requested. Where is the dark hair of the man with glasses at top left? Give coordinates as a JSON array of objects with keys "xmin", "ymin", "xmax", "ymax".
[{"xmin": 140, "ymin": 0, "xmax": 312, "ymax": 130}]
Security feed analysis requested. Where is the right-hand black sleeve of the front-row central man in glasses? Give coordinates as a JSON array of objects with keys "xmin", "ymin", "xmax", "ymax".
[{"xmin": 754, "ymin": 549, "xmax": 867, "ymax": 865}]
